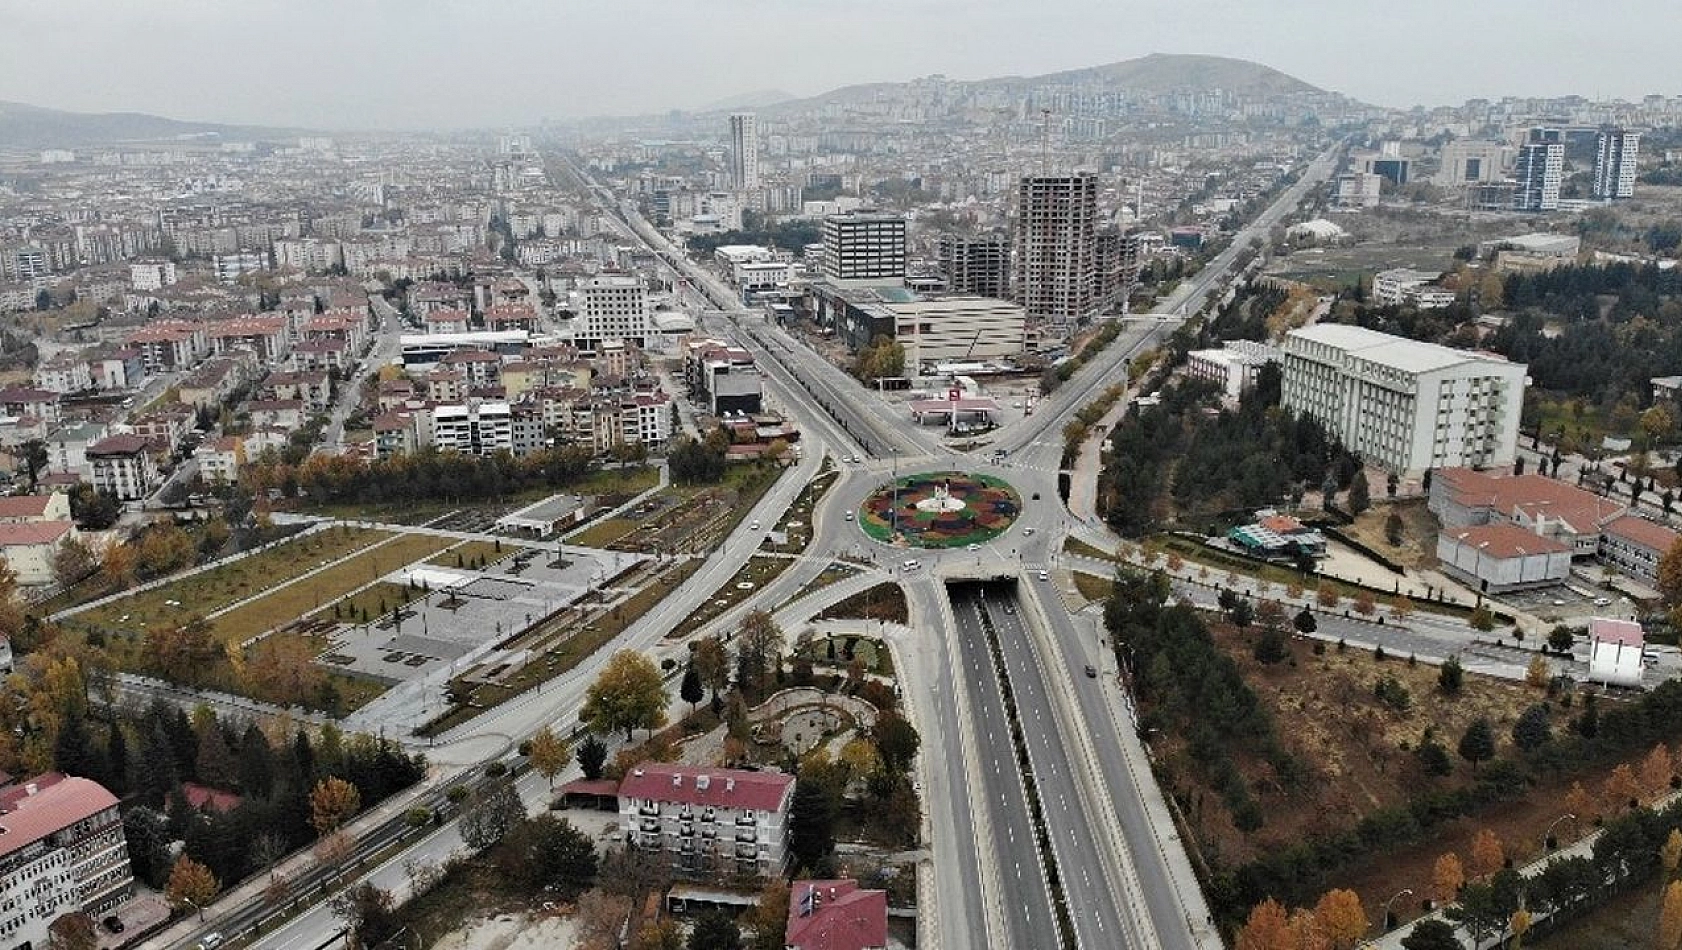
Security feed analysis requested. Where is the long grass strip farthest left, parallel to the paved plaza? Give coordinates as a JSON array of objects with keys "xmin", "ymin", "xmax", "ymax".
[{"xmin": 74, "ymin": 526, "xmax": 392, "ymax": 631}]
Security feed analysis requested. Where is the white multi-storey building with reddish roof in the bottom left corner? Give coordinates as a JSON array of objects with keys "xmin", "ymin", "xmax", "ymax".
[{"xmin": 0, "ymin": 772, "xmax": 135, "ymax": 947}]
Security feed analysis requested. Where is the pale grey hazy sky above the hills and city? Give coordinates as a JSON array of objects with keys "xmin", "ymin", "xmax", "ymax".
[{"xmin": 0, "ymin": 0, "xmax": 1682, "ymax": 128}]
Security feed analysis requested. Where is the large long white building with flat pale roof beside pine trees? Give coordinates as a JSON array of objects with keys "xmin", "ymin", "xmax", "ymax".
[{"xmin": 1282, "ymin": 323, "xmax": 1527, "ymax": 472}]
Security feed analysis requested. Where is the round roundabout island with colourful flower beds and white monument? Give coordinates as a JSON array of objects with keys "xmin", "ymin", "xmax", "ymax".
[{"xmin": 858, "ymin": 472, "xmax": 1023, "ymax": 548}]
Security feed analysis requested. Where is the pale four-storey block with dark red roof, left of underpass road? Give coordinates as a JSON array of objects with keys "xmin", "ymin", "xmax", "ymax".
[{"xmin": 619, "ymin": 762, "xmax": 794, "ymax": 876}]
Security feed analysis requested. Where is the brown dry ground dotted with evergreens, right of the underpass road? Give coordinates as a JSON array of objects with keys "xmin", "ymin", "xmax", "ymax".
[{"xmin": 1156, "ymin": 624, "xmax": 1638, "ymax": 918}]
